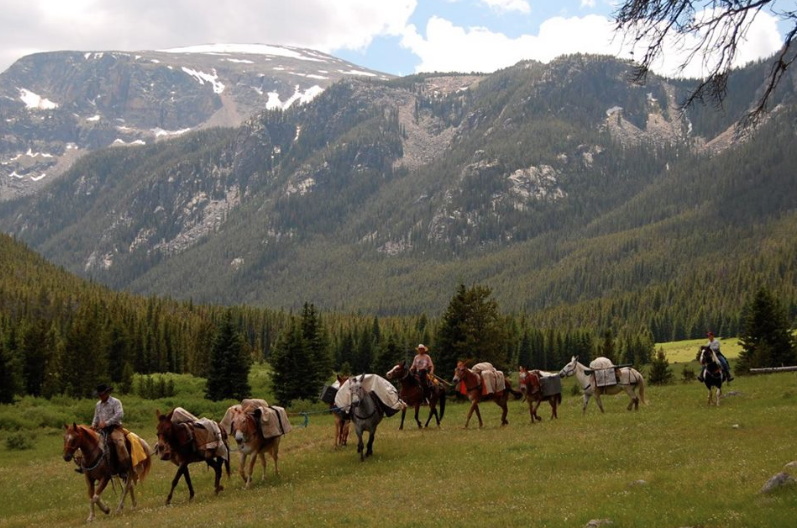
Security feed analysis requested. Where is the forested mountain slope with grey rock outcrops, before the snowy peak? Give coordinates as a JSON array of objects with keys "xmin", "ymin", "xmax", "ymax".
[{"xmin": 0, "ymin": 55, "xmax": 797, "ymax": 341}]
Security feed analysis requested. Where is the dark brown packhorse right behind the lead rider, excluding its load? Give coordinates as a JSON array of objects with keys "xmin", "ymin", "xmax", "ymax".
[{"xmin": 155, "ymin": 410, "xmax": 230, "ymax": 505}]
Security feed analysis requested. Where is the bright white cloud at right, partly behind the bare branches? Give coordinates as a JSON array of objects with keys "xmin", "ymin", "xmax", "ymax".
[{"xmin": 401, "ymin": 12, "xmax": 782, "ymax": 77}]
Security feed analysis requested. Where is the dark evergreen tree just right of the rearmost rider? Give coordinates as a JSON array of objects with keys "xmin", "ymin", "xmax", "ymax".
[{"xmin": 736, "ymin": 287, "xmax": 797, "ymax": 372}]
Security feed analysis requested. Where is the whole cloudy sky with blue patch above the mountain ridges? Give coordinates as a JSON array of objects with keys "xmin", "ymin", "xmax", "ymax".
[{"xmin": 0, "ymin": 0, "xmax": 784, "ymax": 76}]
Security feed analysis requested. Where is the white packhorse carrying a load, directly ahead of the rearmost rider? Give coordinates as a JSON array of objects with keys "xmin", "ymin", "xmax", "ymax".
[{"xmin": 559, "ymin": 356, "xmax": 647, "ymax": 414}]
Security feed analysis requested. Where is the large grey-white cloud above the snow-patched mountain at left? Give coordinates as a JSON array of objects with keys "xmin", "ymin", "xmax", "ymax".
[{"xmin": 0, "ymin": 0, "xmax": 417, "ymax": 71}]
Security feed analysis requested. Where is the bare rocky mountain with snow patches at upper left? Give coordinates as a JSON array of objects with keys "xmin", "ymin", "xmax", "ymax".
[{"xmin": 0, "ymin": 45, "xmax": 387, "ymax": 200}]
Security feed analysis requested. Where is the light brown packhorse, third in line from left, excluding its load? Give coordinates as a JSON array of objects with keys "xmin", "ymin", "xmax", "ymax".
[{"xmin": 230, "ymin": 406, "xmax": 282, "ymax": 489}]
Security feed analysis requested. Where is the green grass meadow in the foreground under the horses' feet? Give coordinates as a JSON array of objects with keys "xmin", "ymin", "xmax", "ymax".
[{"xmin": 0, "ymin": 368, "xmax": 797, "ymax": 528}]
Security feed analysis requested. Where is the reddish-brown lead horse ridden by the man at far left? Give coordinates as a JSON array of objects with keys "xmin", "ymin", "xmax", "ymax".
[{"xmin": 64, "ymin": 422, "xmax": 152, "ymax": 522}]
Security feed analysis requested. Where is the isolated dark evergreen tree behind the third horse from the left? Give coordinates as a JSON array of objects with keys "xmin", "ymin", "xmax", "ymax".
[{"xmin": 205, "ymin": 310, "xmax": 252, "ymax": 401}]
